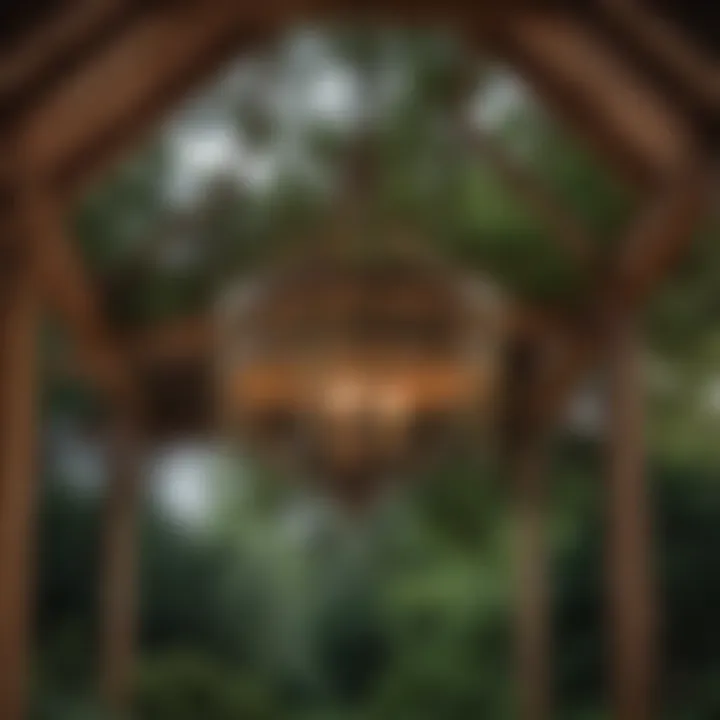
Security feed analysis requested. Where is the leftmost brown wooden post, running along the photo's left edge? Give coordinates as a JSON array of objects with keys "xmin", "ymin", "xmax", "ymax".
[{"xmin": 0, "ymin": 208, "xmax": 40, "ymax": 720}]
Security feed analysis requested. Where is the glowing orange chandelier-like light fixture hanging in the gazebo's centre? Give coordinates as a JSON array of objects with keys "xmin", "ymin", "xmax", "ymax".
[{"xmin": 218, "ymin": 246, "xmax": 504, "ymax": 502}]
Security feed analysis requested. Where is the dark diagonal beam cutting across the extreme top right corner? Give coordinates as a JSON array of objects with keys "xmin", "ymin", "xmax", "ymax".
[{"xmin": 600, "ymin": 0, "xmax": 720, "ymax": 114}]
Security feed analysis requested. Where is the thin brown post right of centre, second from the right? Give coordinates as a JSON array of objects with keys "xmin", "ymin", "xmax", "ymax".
[{"xmin": 510, "ymin": 348, "xmax": 552, "ymax": 720}]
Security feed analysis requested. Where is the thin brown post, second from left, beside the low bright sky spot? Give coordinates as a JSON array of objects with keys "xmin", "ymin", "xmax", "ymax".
[{"xmin": 101, "ymin": 406, "xmax": 143, "ymax": 718}]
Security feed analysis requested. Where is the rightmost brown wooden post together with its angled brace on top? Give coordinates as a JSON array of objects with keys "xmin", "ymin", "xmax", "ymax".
[{"xmin": 604, "ymin": 173, "xmax": 718, "ymax": 720}]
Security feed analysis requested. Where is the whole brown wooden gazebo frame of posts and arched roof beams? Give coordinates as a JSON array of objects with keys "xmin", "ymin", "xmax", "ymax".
[{"xmin": 0, "ymin": 0, "xmax": 720, "ymax": 720}]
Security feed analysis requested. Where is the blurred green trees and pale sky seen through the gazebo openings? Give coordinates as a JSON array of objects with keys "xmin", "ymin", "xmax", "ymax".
[{"xmin": 26, "ymin": 22, "xmax": 720, "ymax": 720}]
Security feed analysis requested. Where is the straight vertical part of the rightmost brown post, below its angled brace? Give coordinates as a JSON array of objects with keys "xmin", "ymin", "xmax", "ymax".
[{"xmin": 606, "ymin": 313, "xmax": 658, "ymax": 720}]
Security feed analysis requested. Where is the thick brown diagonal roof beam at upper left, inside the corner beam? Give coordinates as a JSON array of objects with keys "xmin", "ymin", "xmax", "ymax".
[{"xmin": 20, "ymin": 0, "xmax": 292, "ymax": 195}]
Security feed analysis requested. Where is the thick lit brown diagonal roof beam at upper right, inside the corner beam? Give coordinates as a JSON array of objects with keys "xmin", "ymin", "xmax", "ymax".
[{"xmin": 496, "ymin": 12, "xmax": 696, "ymax": 187}]
